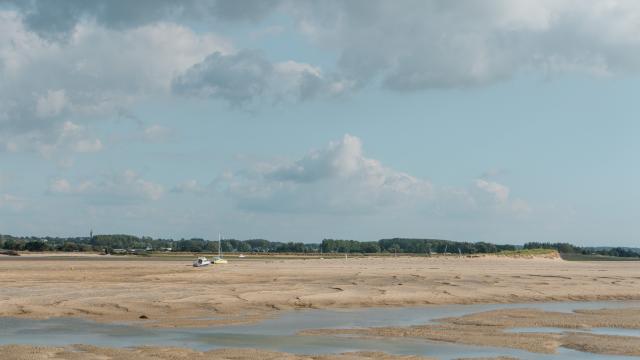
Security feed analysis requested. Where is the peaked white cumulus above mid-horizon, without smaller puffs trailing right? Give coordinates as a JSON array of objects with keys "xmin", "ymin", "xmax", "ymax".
[{"xmin": 225, "ymin": 135, "xmax": 433, "ymax": 213}]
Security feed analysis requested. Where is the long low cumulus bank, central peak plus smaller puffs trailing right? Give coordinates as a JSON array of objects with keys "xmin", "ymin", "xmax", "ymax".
[{"xmin": 218, "ymin": 134, "xmax": 531, "ymax": 216}]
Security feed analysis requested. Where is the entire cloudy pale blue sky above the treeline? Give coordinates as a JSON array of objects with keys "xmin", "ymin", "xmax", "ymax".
[{"xmin": 0, "ymin": 0, "xmax": 640, "ymax": 246}]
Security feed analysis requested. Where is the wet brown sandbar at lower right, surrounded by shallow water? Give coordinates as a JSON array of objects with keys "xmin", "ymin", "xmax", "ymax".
[{"xmin": 302, "ymin": 308, "xmax": 640, "ymax": 355}]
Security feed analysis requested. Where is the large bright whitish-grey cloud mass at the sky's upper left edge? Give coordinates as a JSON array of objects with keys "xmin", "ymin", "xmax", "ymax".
[{"xmin": 0, "ymin": 10, "xmax": 231, "ymax": 151}]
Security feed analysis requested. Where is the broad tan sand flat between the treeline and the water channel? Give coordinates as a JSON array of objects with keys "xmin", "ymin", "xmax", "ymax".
[{"xmin": 0, "ymin": 257, "xmax": 640, "ymax": 327}]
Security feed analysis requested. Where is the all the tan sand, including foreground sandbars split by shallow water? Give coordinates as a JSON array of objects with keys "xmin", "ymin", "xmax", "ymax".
[{"xmin": 0, "ymin": 256, "xmax": 640, "ymax": 360}]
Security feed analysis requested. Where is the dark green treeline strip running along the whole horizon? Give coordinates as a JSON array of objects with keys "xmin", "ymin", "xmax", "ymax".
[{"xmin": 0, "ymin": 234, "xmax": 640, "ymax": 257}]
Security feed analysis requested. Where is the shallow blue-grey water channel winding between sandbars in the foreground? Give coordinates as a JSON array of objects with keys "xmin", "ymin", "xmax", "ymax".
[{"xmin": 0, "ymin": 302, "xmax": 640, "ymax": 360}]
